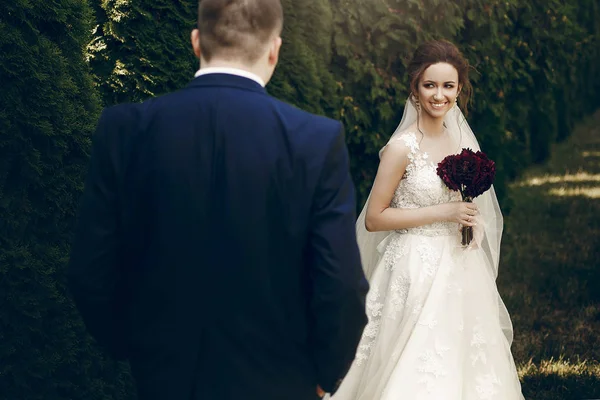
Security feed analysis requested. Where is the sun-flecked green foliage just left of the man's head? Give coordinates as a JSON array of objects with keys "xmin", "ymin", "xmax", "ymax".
[{"xmin": 88, "ymin": 0, "xmax": 198, "ymax": 105}]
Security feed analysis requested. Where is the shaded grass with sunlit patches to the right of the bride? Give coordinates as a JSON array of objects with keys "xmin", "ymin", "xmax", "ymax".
[{"xmin": 498, "ymin": 111, "xmax": 600, "ymax": 400}]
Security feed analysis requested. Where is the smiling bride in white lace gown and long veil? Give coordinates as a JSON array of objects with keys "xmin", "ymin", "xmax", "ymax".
[{"xmin": 333, "ymin": 41, "xmax": 523, "ymax": 400}]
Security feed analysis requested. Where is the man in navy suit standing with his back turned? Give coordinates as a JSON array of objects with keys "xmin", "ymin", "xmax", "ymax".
[{"xmin": 69, "ymin": 0, "xmax": 368, "ymax": 400}]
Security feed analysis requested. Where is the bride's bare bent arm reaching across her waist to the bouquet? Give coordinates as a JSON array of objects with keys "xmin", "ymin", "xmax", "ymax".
[{"xmin": 365, "ymin": 141, "xmax": 477, "ymax": 232}]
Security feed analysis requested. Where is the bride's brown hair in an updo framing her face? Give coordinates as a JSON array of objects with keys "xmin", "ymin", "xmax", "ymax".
[{"xmin": 407, "ymin": 40, "xmax": 473, "ymax": 115}]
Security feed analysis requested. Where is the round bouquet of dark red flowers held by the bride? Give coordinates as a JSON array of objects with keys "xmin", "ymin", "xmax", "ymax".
[{"xmin": 437, "ymin": 149, "xmax": 496, "ymax": 246}]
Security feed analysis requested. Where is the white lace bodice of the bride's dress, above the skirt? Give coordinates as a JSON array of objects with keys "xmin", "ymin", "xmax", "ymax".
[{"xmin": 390, "ymin": 132, "xmax": 461, "ymax": 236}]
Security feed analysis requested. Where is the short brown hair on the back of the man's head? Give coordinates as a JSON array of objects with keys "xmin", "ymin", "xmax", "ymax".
[{"xmin": 198, "ymin": 0, "xmax": 283, "ymax": 64}]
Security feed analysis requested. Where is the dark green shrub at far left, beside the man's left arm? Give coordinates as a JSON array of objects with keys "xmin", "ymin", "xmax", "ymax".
[{"xmin": 0, "ymin": 0, "xmax": 132, "ymax": 400}]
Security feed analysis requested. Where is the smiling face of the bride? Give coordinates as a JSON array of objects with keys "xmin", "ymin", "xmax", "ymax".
[{"xmin": 418, "ymin": 62, "xmax": 459, "ymax": 119}]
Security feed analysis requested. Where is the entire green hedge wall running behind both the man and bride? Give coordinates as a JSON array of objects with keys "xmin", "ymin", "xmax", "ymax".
[{"xmin": 0, "ymin": 0, "xmax": 600, "ymax": 400}]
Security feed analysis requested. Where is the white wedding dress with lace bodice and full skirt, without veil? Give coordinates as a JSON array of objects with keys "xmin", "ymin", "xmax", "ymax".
[{"xmin": 332, "ymin": 101, "xmax": 523, "ymax": 400}]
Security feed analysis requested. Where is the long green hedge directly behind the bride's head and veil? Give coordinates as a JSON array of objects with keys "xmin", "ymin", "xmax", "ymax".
[{"xmin": 332, "ymin": 0, "xmax": 600, "ymax": 206}]
